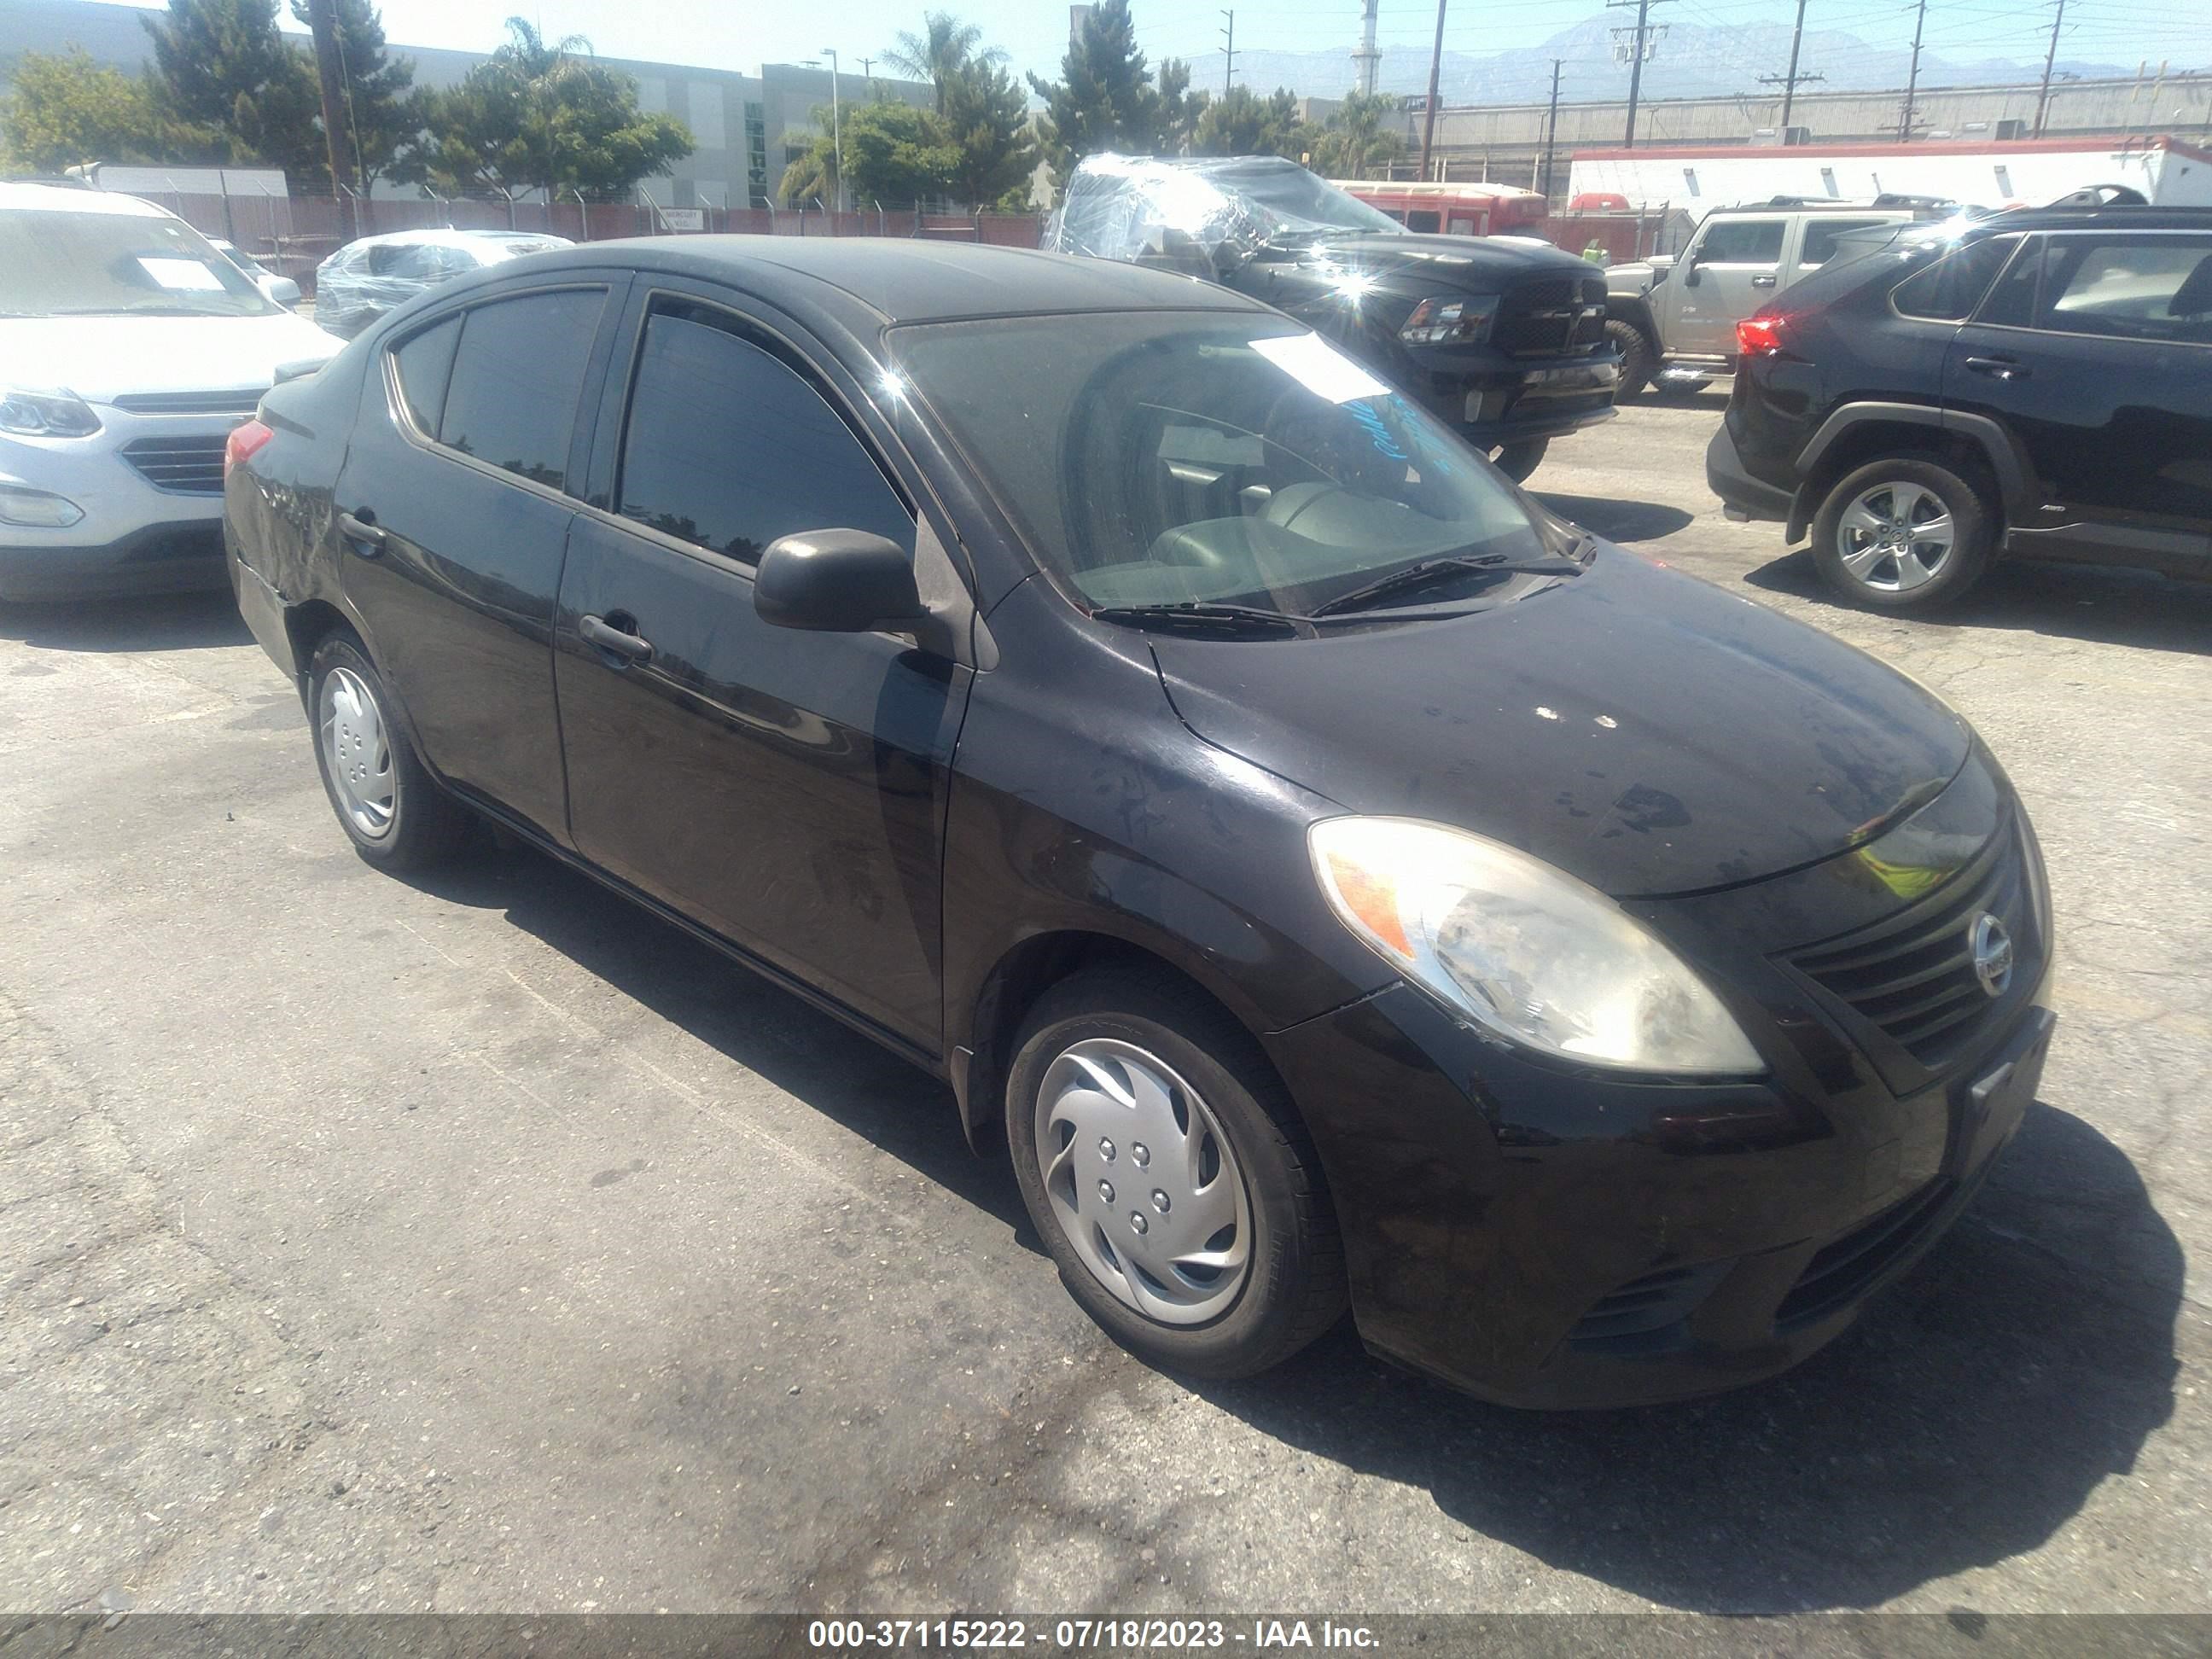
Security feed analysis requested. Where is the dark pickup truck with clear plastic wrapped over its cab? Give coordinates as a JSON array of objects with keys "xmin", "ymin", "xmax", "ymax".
[{"xmin": 1044, "ymin": 154, "xmax": 1619, "ymax": 478}]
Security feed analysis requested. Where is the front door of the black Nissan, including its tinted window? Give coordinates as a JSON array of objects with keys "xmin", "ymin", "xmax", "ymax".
[{"xmin": 556, "ymin": 294, "xmax": 969, "ymax": 1053}]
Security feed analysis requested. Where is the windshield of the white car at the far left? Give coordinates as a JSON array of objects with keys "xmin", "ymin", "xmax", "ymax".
[{"xmin": 0, "ymin": 208, "xmax": 279, "ymax": 317}]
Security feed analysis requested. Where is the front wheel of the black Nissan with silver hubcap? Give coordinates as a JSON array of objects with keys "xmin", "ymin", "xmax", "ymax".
[{"xmin": 1004, "ymin": 967, "xmax": 1345, "ymax": 1378}]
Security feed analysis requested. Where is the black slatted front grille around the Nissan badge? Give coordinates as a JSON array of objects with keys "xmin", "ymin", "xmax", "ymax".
[{"xmin": 1794, "ymin": 825, "xmax": 2041, "ymax": 1071}]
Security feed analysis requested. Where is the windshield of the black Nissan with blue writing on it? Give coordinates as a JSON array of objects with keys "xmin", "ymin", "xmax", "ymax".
[{"xmin": 889, "ymin": 311, "xmax": 1570, "ymax": 617}]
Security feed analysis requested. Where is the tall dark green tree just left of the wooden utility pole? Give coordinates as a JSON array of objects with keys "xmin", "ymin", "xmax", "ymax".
[{"xmin": 139, "ymin": 0, "xmax": 329, "ymax": 179}]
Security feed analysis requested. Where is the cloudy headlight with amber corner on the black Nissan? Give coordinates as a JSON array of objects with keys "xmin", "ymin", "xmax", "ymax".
[{"xmin": 1307, "ymin": 818, "xmax": 1765, "ymax": 1075}]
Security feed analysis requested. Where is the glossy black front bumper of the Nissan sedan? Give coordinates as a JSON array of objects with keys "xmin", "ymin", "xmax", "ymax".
[{"xmin": 1266, "ymin": 787, "xmax": 2055, "ymax": 1407}]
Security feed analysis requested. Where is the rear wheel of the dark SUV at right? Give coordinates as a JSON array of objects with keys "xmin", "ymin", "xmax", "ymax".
[{"xmin": 1812, "ymin": 456, "xmax": 1998, "ymax": 610}]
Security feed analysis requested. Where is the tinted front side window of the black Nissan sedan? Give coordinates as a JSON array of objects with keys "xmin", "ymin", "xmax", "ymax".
[{"xmin": 617, "ymin": 303, "xmax": 913, "ymax": 564}]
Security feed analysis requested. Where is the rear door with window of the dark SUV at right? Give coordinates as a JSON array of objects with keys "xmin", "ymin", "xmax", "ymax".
[{"xmin": 1942, "ymin": 230, "xmax": 2212, "ymax": 573}]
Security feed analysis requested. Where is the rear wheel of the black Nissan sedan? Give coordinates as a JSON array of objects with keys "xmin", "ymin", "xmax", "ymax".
[{"xmin": 307, "ymin": 632, "xmax": 469, "ymax": 871}]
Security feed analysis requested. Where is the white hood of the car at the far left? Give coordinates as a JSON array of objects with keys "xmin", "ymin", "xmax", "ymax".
[{"xmin": 0, "ymin": 311, "xmax": 345, "ymax": 403}]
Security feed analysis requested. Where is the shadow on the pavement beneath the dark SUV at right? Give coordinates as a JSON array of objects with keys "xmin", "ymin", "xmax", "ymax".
[{"xmin": 1743, "ymin": 542, "xmax": 2212, "ymax": 653}]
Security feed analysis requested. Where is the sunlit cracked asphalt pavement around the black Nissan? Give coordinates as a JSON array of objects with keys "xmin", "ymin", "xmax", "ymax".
[{"xmin": 0, "ymin": 393, "xmax": 2212, "ymax": 1619}]
